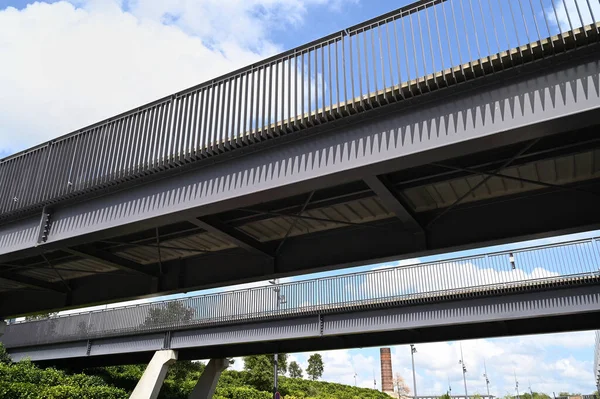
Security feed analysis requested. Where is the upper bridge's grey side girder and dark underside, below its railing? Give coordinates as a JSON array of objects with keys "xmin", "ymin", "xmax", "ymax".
[{"xmin": 0, "ymin": 48, "xmax": 600, "ymax": 318}]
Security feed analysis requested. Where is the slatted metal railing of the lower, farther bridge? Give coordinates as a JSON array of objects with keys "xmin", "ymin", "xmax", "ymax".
[{"xmin": 2, "ymin": 239, "xmax": 600, "ymax": 347}]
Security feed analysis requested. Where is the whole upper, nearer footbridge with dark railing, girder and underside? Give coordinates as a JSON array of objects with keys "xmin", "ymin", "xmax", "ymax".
[{"xmin": 0, "ymin": 0, "xmax": 600, "ymax": 318}]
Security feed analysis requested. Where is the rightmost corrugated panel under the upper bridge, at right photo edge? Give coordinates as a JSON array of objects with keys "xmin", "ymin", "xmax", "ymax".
[{"xmin": 403, "ymin": 150, "xmax": 600, "ymax": 212}]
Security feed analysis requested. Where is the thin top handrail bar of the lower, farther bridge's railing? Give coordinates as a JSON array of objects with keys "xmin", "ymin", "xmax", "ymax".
[{"xmin": 15, "ymin": 236, "xmax": 600, "ymax": 324}]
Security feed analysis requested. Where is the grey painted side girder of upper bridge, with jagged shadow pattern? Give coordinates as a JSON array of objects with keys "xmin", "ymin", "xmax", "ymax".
[{"xmin": 0, "ymin": 50, "xmax": 600, "ymax": 262}]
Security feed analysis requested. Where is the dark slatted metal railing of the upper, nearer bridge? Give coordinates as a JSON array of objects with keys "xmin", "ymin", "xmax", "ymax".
[{"xmin": 0, "ymin": 0, "xmax": 600, "ymax": 216}]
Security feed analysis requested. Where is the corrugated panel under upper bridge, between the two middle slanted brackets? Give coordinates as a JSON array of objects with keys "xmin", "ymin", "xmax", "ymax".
[{"xmin": 239, "ymin": 197, "xmax": 394, "ymax": 241}]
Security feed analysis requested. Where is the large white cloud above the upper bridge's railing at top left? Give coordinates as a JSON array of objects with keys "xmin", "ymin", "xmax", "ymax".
[{"xmin": 0, "ymin": 0, "xmax": 352, "ymax": 152}]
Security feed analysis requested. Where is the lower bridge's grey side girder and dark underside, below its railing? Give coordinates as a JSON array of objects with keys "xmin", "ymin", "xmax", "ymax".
[{"xmin": 8, "ymin": 283, "xmax": 600, "ymax": 368}]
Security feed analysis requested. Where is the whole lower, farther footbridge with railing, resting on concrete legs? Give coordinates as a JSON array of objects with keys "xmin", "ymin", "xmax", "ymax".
[{"xmin": 0, "ymin": 239, "xmax": 600, "ymax": 367}]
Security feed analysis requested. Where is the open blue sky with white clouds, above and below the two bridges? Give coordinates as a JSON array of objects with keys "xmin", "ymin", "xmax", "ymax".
[{"xmin": 0, "ymin": 0, "xmax": 600, "ymax": 395}]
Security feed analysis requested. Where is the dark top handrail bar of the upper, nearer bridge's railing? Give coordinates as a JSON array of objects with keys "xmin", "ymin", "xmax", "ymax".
[{"xmin": 0, "ymin": 0, "xmax": 440, "ymax": 165}]
